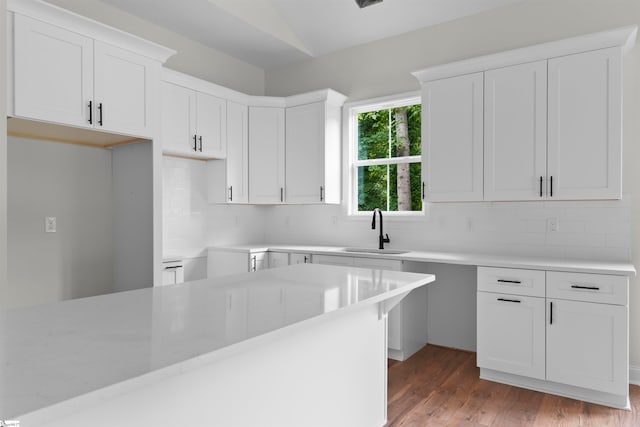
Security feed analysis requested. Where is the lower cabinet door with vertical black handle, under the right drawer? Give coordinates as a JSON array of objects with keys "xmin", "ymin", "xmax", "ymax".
[{"xmin": 547, "ymin": 299, "xmax": 629, "ymax": 395}]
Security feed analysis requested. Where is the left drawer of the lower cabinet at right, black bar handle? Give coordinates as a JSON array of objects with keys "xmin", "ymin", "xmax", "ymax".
[{"xmin": 478, "ymin": 267, "xmax": 545, "ymax": 297}]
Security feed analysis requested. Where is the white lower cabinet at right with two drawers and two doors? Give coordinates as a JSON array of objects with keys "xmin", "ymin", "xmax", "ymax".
[{"xmin": 477, "ymin": 267, "xmax": 629, "ymax": 407}]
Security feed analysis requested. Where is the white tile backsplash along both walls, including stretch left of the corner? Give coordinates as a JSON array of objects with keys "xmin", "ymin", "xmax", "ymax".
[{"xmin": 163, "ymin": 157, "xmax": 631, "ymax": 261}]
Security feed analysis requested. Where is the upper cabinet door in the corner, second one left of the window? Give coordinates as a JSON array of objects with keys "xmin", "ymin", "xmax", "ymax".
[{"xmin": 249, "ymin": 107, "xmax": 286, "ymax": 204}]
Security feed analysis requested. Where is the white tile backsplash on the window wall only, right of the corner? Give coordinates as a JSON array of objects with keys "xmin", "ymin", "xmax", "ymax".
[{"xmin": 266, "ymin": 196, "xmax": 631, "ymax": 261}]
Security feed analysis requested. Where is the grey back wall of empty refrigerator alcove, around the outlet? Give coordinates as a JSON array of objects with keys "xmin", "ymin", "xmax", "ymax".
[{"xmin": 3, "ymin": 137, "xmax": 113, "ymax": 306}]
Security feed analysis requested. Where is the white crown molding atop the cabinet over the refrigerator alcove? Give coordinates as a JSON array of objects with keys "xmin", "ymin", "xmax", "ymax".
[{"xmin": 7, "ymin": 0, "xmax": 176, "ymax": 63}]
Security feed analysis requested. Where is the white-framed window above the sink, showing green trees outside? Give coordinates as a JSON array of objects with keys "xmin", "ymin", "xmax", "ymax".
[{"xmin": 348, "ymin": 95, "xmax": 423, "ymax": 215}]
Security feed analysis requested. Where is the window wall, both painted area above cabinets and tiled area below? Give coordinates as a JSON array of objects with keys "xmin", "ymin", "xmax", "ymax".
[{"xmin": 265, "ymin": 0, "xmax": 640, "ymax": 367}]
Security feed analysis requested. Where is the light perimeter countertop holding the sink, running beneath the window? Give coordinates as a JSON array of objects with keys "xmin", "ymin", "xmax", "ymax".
[{"xmin": 208, "ymin": 244, "xmax": 636, "ymax": 276}]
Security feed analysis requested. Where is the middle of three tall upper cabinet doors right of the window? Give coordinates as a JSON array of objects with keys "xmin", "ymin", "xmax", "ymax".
[{"xmin": 484, "ymin": 61, "xmax": 547, "ymax": 200}]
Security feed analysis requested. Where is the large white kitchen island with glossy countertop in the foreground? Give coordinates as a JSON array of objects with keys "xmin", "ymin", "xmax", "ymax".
[{"xmin": 0, "ymin": 264, "xmax": 435, "ymax": 427}]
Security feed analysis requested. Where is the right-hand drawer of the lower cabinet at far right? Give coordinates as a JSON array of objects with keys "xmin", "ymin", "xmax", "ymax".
[{"xmin": 547, "ymin": 271, "xmax": 629, "ymax": 305}]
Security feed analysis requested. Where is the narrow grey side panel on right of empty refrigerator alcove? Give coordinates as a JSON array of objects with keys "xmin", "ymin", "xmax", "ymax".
[{"xmin": 112, "ymin": 141, "xmax": 153, "ymax": 291}]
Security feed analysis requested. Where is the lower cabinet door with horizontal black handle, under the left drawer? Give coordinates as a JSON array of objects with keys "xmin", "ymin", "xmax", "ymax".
[{"xmin": 477, "ymin": 292, "xmax": 545, "ymax": 379}]
